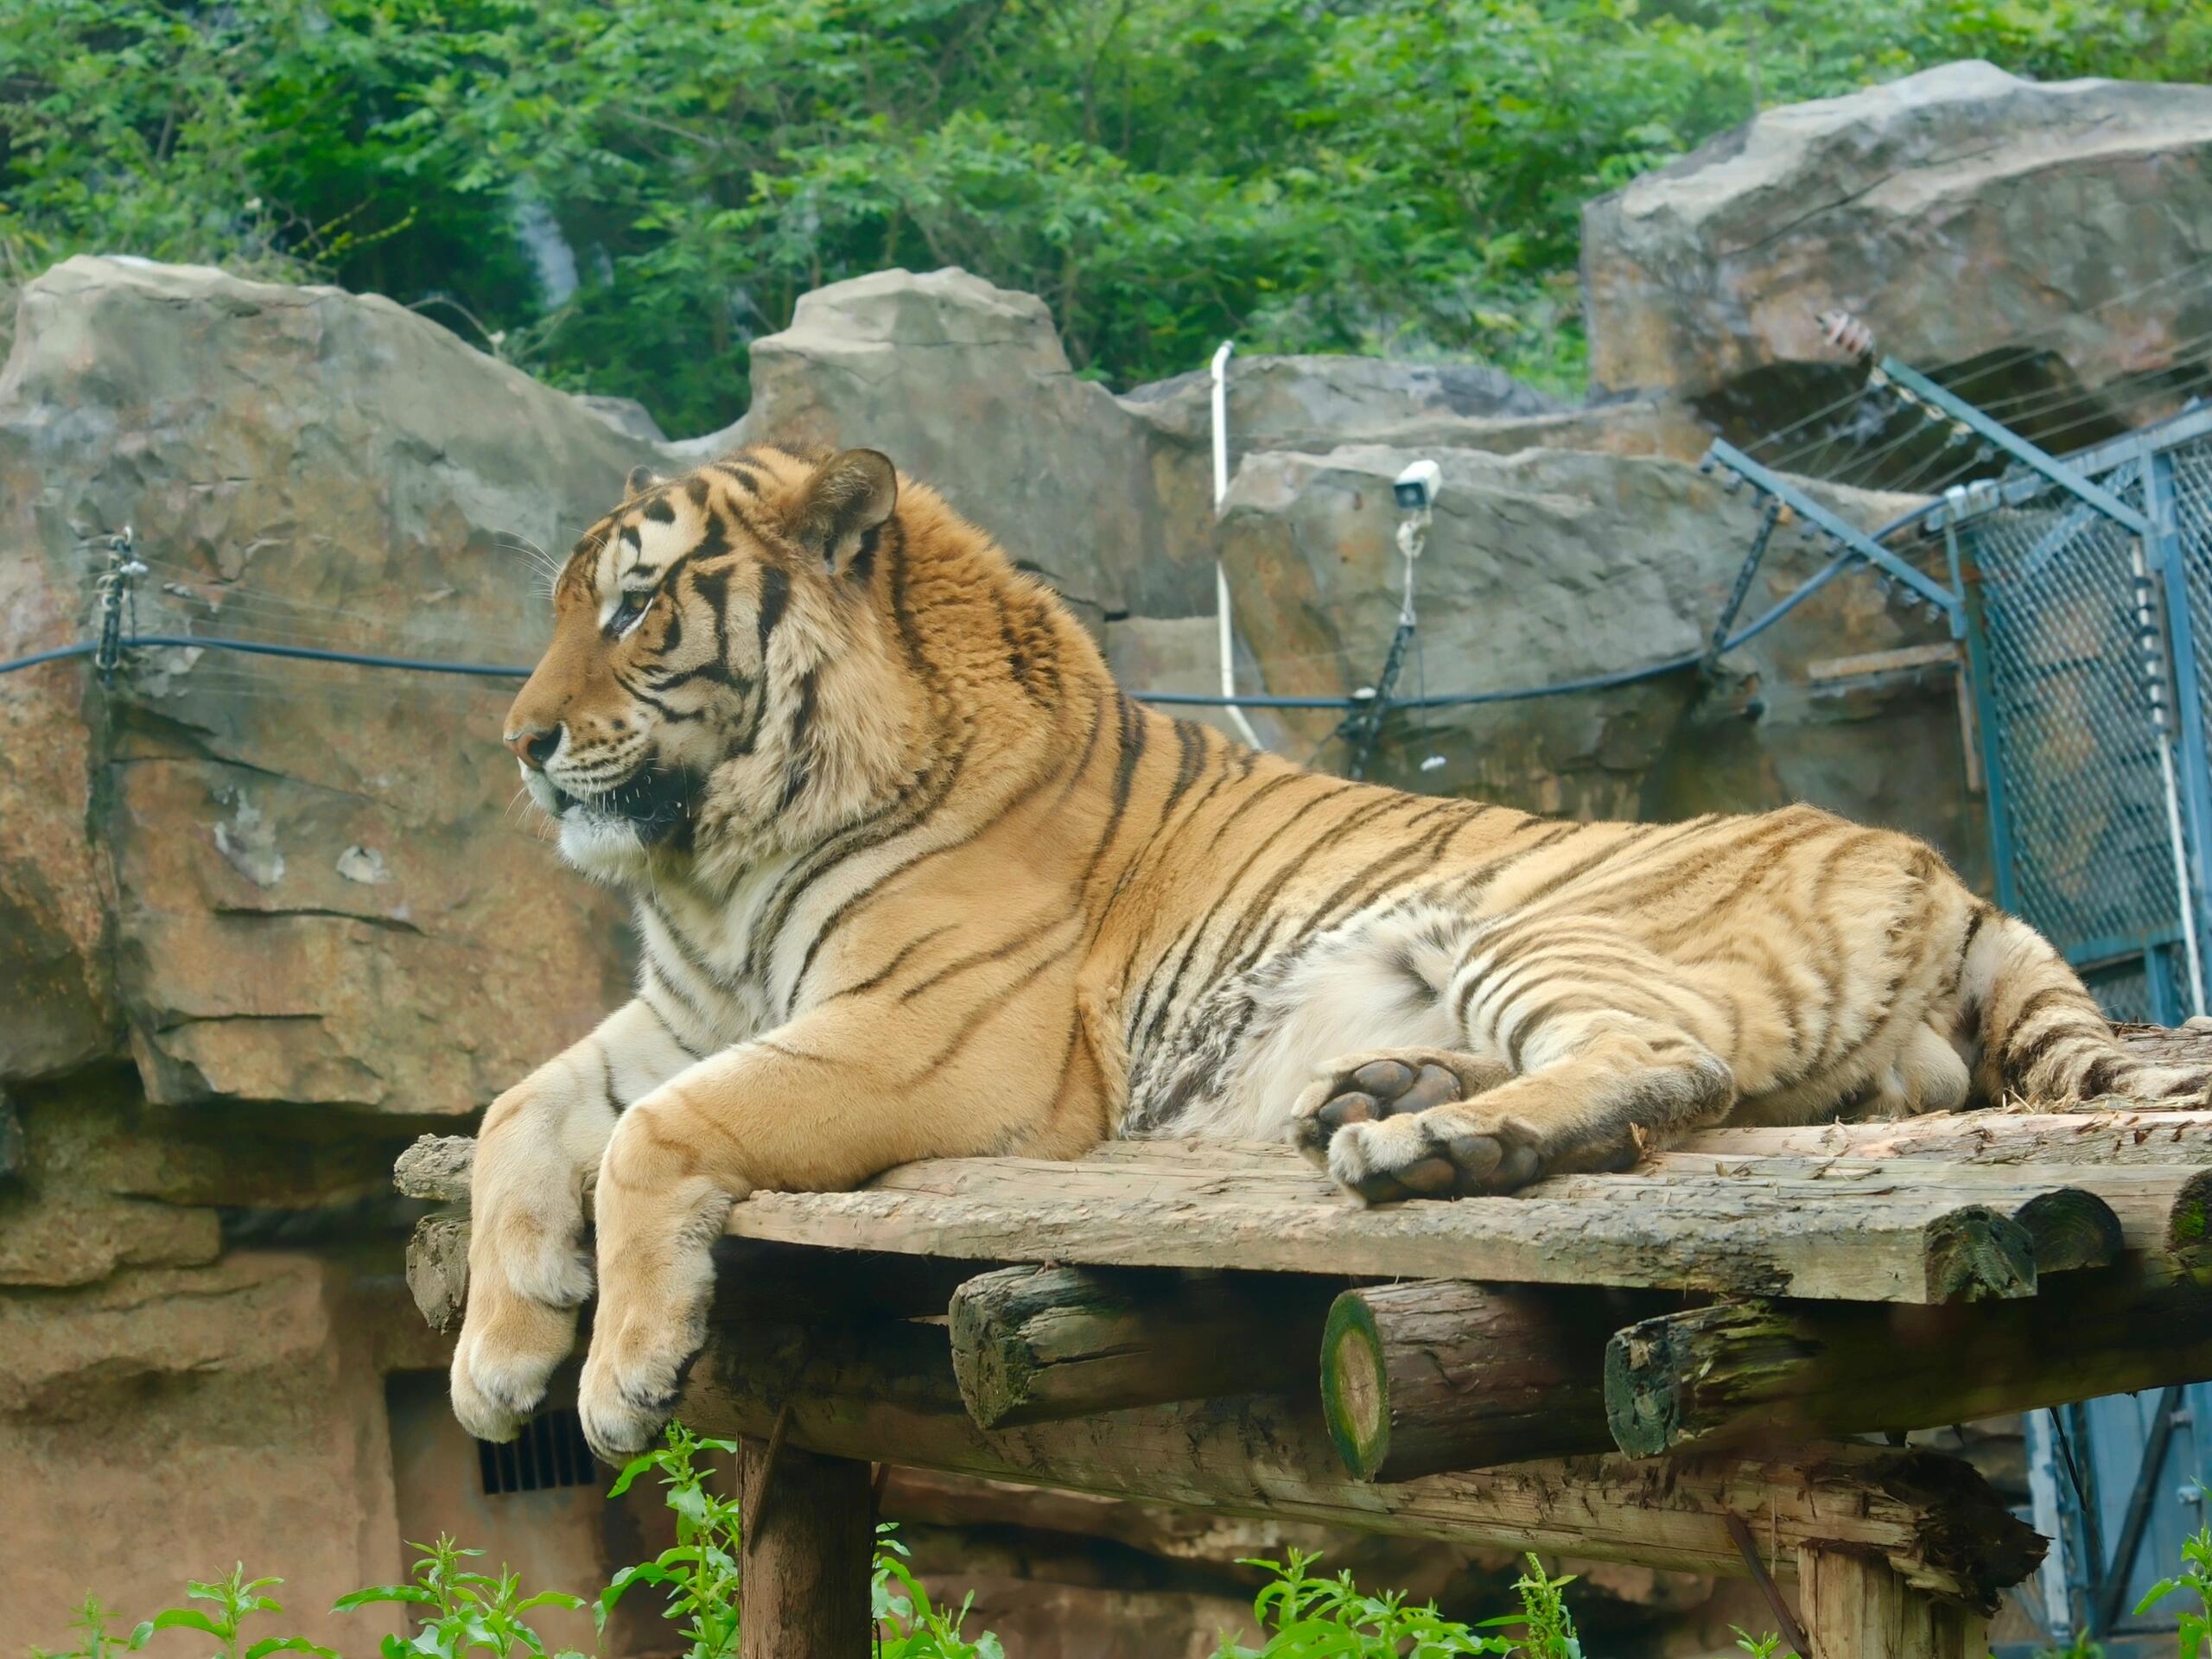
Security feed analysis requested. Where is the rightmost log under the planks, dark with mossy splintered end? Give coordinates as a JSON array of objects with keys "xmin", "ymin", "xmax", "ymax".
[{"xmin": 1604, "ymin": 1259, "xmax": 2212, "ymax": 1458}]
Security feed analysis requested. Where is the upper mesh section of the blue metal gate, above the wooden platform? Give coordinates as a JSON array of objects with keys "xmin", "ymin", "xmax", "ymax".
[{"xmin": 1931, "ymin": 411, "xmax": 2212, "ymax": 1024}]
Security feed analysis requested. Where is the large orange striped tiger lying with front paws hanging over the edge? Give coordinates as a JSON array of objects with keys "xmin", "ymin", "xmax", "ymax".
[{"xmin": 451, "ymin": 445, "xmax": 2205, "ymax": 1458}]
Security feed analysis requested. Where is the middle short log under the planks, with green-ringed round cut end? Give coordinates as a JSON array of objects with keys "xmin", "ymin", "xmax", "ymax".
[{"xmin": 1320, "ymin": 1279, "xmax": 1656, "ymax": 1480}]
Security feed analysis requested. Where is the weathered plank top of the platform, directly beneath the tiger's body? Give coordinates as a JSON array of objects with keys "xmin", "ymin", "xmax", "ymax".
[{"xmin": 403, "ymin": 1113, "xmax": 2212, "ymax": 1303}]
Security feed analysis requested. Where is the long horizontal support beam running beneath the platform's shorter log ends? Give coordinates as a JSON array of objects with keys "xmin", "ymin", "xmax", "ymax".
[{"xmin": 679, "ymin": 1323, "xmax": 2044, "ymax": 1606}]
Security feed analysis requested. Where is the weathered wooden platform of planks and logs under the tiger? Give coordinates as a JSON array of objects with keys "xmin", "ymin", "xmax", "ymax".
[{"xmin": 398, "ymin": 1109, "xmax": 2212, "ymax": 1659}]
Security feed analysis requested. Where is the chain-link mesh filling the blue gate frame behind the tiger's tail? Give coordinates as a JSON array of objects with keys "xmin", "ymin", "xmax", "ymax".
[{"xmin": 1960, "ymin": 451, "xmax": 2212, "ymax": 1020}]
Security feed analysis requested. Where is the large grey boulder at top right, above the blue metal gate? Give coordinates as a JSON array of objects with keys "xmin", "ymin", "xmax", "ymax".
[{"xmin": 1581, "ymin": 62, "xmax": 2212, "ymax": 447}]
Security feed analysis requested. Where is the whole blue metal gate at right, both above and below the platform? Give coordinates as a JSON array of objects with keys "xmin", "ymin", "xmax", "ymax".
[{"xmin": 1931, "ymin": 400, "xmax": 2212, "ymax": 1659}]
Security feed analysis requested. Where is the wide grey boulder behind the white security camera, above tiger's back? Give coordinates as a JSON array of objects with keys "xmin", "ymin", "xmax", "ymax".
[{"xmin": 1219, "ymin": 445, "xmax": 1986, "ymax": 878}]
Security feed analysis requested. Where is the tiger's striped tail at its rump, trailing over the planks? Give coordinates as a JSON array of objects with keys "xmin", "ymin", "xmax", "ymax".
[{"xmin": 1960, "ymin": 909, "xmax": 2212, "ymax": 1106}]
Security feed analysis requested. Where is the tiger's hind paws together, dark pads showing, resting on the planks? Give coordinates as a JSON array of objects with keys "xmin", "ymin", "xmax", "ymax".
[{"xmin": 1292, "ymin": 1048, "xmax": 1544, "ymax": 1204}]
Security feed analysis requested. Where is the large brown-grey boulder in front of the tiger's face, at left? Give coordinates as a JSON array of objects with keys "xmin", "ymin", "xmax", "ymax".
[{"xmin": 0, "ymin": 259, "xmax": 645, "ymax": 1119}]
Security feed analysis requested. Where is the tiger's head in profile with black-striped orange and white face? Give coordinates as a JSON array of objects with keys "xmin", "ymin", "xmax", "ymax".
[{"xmin": 505, "ymin": 447, "xmax": 913, "ymax": 882}]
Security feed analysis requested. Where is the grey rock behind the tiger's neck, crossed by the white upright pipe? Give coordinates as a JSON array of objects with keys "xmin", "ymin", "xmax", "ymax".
[{"xmin": 698, "ymin": 270, "xmax": 1566, "ymax": 624}]
